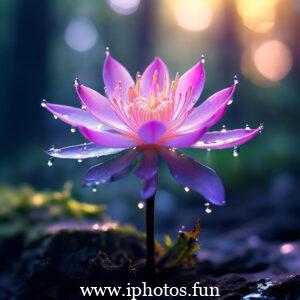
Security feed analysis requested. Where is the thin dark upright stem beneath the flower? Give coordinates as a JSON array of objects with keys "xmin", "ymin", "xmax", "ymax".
[{"xmin": 146, "ymin": 194, "xmax": 155, "ymax": 274}]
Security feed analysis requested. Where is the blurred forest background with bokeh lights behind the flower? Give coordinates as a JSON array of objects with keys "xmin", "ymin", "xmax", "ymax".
[{"xmin": 0, "ymin": 0, "xmax": 300, "ymax": 239}]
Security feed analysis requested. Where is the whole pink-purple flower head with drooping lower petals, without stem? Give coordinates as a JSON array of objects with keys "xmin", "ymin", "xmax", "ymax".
[{"xmin": 43, "ymin": 53, "xmax": 262, "ymax": 205}]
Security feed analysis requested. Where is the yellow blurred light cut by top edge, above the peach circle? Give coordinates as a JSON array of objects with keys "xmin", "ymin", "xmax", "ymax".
[{"xmin": 237, "ymin": 0, "xmax": 278, "ymax": 33}]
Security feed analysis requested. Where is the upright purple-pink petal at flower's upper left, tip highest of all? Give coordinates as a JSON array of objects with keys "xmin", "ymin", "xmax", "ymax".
[{"xmin": 103, "ymin": 54, "xmax": 134, "ymax": 99}]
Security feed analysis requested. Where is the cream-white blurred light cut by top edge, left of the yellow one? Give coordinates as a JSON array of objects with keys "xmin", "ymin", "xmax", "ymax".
[{"xmin": 172, "ymin": 0, "xmax": 213, "ymax": 31}]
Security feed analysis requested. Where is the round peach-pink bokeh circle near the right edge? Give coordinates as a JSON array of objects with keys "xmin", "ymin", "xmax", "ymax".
[{"xmin": 254, "ymin": 40, "xmax": 292, "ymax": 81}]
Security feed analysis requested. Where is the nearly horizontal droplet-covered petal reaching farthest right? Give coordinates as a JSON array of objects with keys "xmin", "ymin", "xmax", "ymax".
[{"xmin": 192, "ymin": 127, "xmax": 262, "ymax": 149}]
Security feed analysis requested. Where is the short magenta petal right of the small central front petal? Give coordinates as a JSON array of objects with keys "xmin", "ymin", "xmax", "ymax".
[{"xmin": 161, "ymin": 127, "xmax": 207, "ymax": 148}]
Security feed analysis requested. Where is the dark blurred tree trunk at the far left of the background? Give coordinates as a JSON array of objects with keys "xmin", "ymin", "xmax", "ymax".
[{"xmin": 0, "ymin": 0, "xmax": 50, "ymax": 157}]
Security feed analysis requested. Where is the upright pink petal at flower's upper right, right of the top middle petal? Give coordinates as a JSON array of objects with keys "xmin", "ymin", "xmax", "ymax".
[{"xmin": 174, "ymin": 62, "xmax": 205, "ymax": 117}]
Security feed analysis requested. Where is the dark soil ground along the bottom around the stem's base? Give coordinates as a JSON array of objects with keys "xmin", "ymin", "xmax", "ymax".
[{"xmin": 0, "ymin": 228, "xmax": 300, "ymax": 300}]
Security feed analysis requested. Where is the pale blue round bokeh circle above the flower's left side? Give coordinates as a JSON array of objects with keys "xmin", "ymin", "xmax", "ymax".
[{"xmin": 65, "ymin": 17, "xmax": 98, "ymax": 52}]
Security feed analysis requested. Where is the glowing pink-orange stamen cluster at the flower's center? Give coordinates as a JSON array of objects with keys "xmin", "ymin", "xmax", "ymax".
[{"xmin": 114, "ymin": 71, "xmax": 194, "ymax": 131}]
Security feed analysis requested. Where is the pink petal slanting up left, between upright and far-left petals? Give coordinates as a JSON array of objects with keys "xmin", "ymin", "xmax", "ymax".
[{"xmin": 75, "ymin": 81, "xmax": 128, "ymax": 132}]
